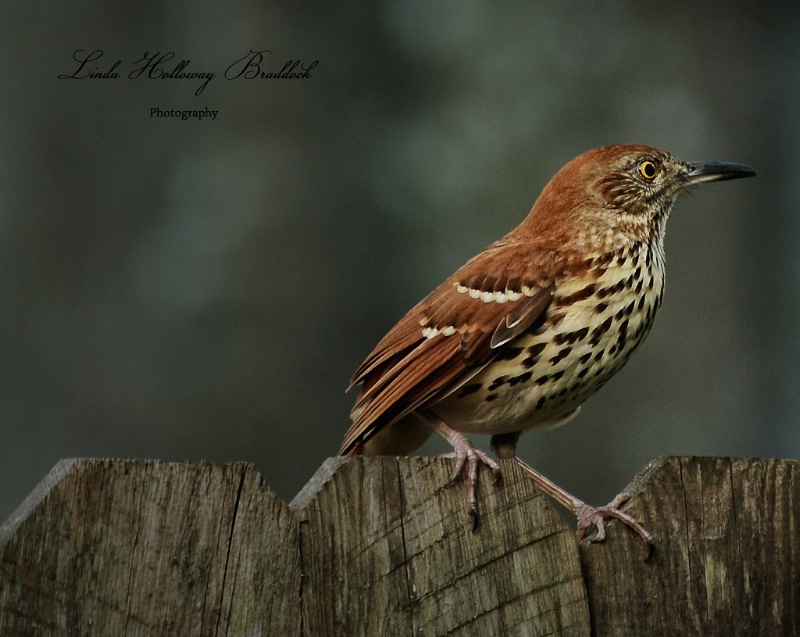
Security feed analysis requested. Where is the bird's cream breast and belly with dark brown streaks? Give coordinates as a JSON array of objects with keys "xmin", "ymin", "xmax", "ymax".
[{"xmin": 434, "ymin": 246, "xmax": 664, "ymax": 434}]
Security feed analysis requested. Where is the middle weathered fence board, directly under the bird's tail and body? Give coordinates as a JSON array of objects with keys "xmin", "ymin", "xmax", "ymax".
[{"xmin": 291, "ymin": 457, "xmax": 589, "ymax": 635}]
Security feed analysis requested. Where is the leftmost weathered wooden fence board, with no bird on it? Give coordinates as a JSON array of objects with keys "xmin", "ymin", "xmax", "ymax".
[{"xmin": 0, "ymin": 460, "xmax": 300, "ymax": 635}]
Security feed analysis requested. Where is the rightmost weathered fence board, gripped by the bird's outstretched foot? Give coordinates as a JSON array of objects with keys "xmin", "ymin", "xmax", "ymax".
[{"xmin": 581, "ymin": 457, "xmax": 800, "ymax": 636}]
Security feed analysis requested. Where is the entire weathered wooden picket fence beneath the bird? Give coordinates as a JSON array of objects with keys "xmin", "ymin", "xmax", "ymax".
[{"xmin": 0, "ymin": 457, "xmax": 800, "ymax": 637}]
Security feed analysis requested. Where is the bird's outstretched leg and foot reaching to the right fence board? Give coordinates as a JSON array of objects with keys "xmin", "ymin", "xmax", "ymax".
[{"xmin": 514, "ymin": 456, "xmax": 653, "ymax": 550}]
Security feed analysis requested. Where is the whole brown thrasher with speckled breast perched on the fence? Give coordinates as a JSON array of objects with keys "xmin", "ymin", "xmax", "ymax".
[{"xmin": 339, "ymin": 145, "xmax": 755, "ymax": 543}]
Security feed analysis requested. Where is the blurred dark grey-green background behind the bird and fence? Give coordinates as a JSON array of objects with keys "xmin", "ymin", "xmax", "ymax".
[{"xmin": 0, "ymin": 0, "xmax": 800, "ymax": 521}]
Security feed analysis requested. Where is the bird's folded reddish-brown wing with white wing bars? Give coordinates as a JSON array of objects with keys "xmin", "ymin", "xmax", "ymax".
[{"xmin": 339, "ymin": 242, "xmax": 555, "ymax": 454}]
